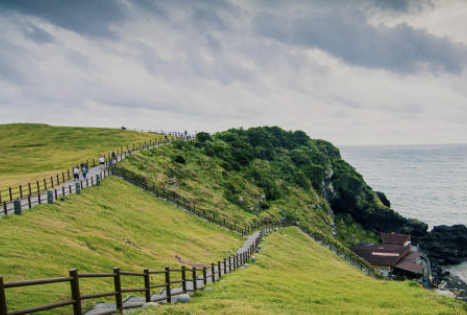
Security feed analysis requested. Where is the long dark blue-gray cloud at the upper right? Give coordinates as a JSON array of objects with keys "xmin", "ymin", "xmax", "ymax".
[{"xmin": 255, "ymin": 10, "xmax": 467, "ymax": 73}]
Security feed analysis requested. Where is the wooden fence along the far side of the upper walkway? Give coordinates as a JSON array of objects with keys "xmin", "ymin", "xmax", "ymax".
[{"xmin": 0, "ymin": 136, "xmax": 177, "ymax": 207}]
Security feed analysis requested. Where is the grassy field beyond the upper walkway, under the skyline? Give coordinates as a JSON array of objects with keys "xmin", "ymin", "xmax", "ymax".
[{"xmin": 0, "ymin": 124, "xmax": 166, "ymax": 188}]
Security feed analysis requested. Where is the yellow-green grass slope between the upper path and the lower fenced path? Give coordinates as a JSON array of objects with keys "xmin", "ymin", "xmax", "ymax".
[{"xmin": 0, "ymin": 178, "xmax": 243, "ymax": 314}]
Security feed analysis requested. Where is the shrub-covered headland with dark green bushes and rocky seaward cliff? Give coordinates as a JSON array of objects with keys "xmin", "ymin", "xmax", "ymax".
[{"xmin": 118, "ymin": 127, "xmax": 424, "ymax": 245}]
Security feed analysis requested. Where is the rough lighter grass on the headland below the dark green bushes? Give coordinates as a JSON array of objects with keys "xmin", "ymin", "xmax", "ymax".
[{"xmin": 118, "ymin": 144, "xmax": 329, "ymax": 236}]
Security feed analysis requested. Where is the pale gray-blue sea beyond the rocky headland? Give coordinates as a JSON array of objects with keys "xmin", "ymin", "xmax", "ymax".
[{"xmin": 339, "ymin": 144, "xmax": 467, "ymax": 282}]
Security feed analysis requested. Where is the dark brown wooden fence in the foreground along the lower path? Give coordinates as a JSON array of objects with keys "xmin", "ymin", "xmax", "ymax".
[{"xmin": 0, "ymin": 224, "xmax": 282, "ymax": 315}]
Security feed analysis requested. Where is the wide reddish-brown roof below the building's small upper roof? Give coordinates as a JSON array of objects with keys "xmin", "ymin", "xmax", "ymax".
[{"xmin": 350, "ymin": 244, "xmax": 410, "ymax": 266}]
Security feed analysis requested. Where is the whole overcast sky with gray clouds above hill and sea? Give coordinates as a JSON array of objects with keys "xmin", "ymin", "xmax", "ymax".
[{"xmin": 0, "ymin": 0, "xmax": 467, "ymax": 145}]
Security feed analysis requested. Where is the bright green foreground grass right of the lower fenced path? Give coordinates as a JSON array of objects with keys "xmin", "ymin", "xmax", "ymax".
[{"xmin": 138, "ymin": 228, "xmax": 467, "ymax": 315}]
